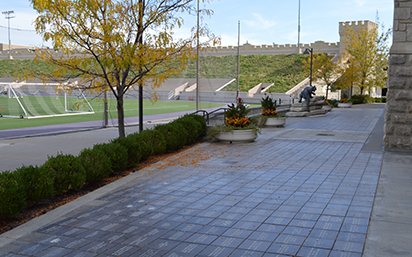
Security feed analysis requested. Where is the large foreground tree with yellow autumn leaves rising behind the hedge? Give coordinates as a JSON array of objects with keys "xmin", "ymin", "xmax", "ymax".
[{"xmin": 24, "ymin": 0, "xmax": 219, "ymax": 137}]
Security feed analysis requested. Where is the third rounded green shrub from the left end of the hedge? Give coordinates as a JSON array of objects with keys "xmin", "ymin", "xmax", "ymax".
[{"xmin": 43, "ymin": 154, "xmax": 86, "ymax": 194}]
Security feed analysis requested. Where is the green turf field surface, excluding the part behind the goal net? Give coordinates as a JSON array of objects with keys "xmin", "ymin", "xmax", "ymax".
[{"xmin": 0, "ymin": 99, "xmax": 225, "ymax": 130}]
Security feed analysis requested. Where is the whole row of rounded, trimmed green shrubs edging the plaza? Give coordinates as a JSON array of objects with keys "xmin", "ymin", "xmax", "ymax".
[{"xmin": 0, "ymin": 115, "xmax": 207, "ymax": 217}]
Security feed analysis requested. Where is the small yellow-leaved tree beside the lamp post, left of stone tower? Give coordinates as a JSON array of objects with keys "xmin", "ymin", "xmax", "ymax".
[{"xmin": 302, "ymin": 53, "xmax": 339, "ymax": 99}]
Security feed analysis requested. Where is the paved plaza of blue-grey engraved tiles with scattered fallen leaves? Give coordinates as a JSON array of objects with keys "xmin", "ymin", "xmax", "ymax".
[{"xmin": 0, "ymin": 104, "xmax": 412, "ymax": 257}]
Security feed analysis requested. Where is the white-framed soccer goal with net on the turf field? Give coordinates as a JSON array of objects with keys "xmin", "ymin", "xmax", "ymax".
[{"xmin": 0, "ymin": 82, "xmax": 94, "ymax": 119}]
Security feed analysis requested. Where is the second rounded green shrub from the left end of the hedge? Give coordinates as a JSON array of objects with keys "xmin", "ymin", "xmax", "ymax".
[{"xmin": 14, "ymin": 165, "xmax": 54, "ymax": 204}]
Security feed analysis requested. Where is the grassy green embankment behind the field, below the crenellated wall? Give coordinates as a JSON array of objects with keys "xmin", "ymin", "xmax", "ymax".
[{"xmin": 0, "ymin": 54, "xmax": 307, "ymax": 93}]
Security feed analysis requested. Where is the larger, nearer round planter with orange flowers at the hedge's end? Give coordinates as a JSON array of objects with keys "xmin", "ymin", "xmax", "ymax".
[{"xmin": 206, "ymin": 98, "xmax": 260, "ymax": 143}]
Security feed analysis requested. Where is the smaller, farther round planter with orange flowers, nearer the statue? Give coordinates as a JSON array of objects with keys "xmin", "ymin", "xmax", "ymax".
[{"xmin": 257, "ymin": 95, "xmax": 286, "ymax": 127}]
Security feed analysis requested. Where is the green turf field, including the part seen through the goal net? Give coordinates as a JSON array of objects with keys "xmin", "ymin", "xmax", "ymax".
[{"xmin": 0, "ymin": 97, "xmax": 225, "ymax": 130}]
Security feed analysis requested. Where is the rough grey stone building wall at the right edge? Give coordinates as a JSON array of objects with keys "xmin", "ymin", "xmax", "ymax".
[{"xmin": 383, "ymin": 0, "xmax": 412, "ymax": 149}]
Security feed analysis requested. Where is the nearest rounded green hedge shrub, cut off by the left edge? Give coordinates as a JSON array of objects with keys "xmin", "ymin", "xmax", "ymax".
[{"xmin": 0, "ymin": 171, "xmax": 26, "ymax": 217}]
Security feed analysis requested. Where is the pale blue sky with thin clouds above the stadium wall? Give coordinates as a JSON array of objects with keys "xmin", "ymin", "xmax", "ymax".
[{"xmin": 0, "ymin": 0, "xmax": 394, "ymax": 47}]
